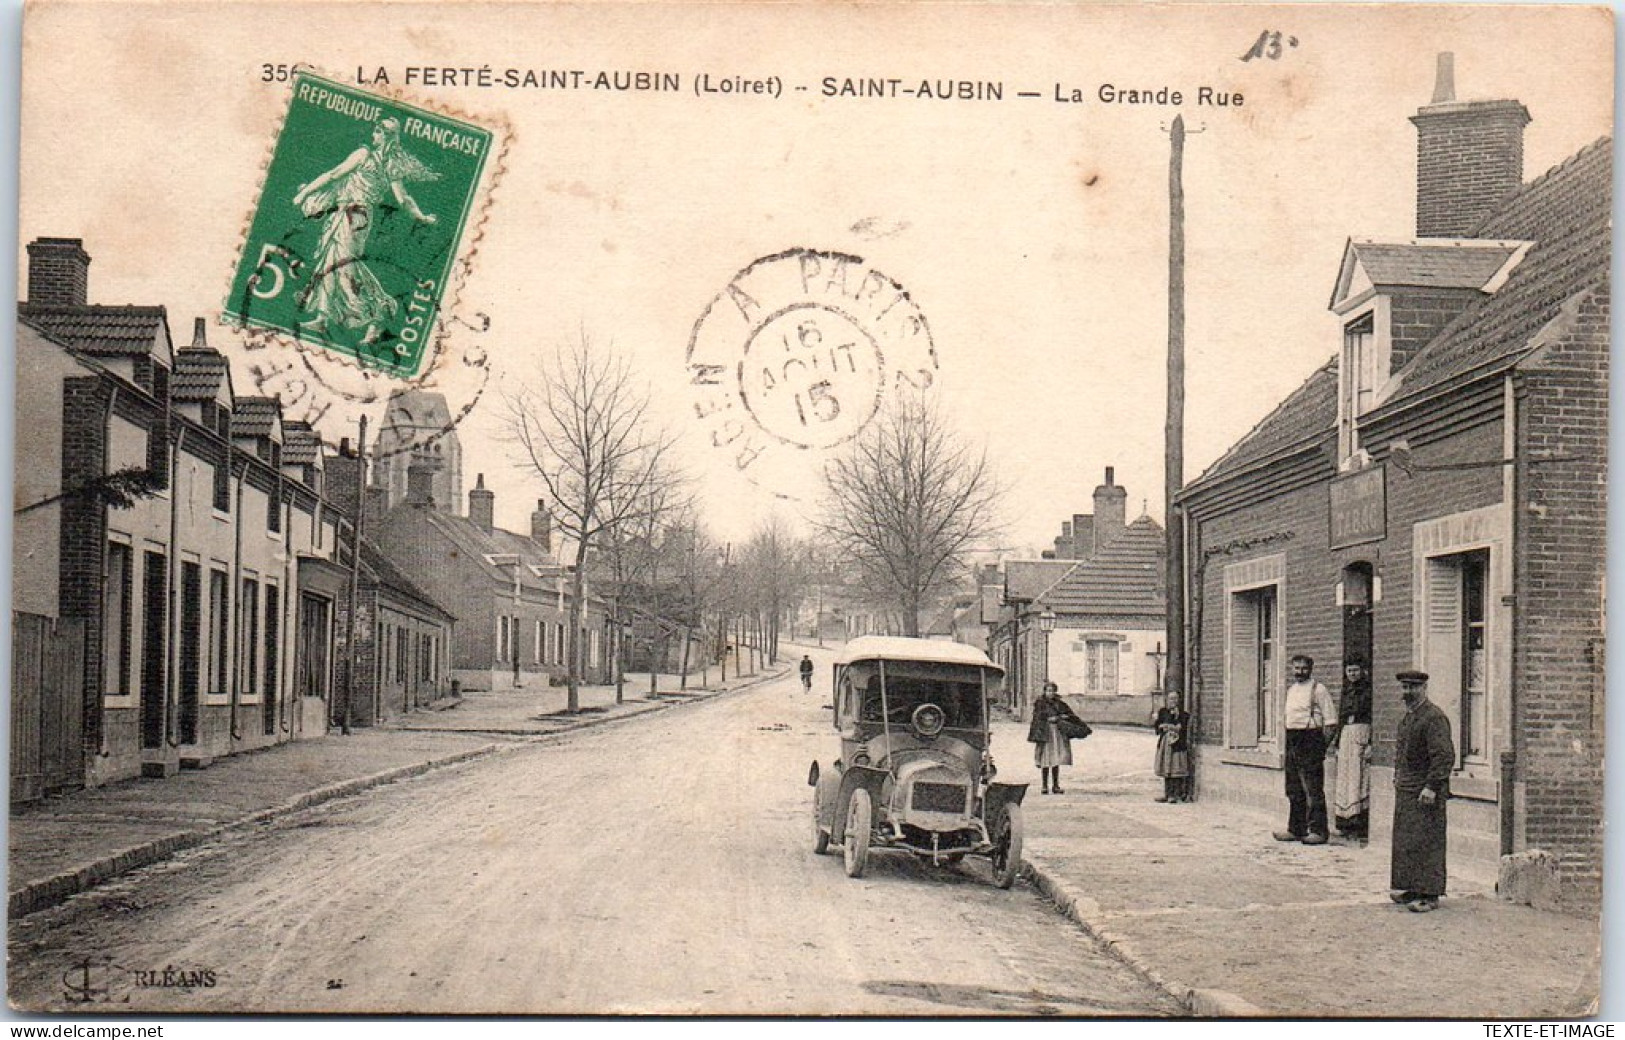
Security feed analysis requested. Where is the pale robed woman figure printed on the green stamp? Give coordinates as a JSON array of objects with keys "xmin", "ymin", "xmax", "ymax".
[{"xmin": 294, "ymin": 119, "xmax": 439, "ymax": 346}]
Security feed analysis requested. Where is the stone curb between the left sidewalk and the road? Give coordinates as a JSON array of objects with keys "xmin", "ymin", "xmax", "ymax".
[{"xmin": 7, "ymin": 668, "xmax": 790, "ymax": 921}]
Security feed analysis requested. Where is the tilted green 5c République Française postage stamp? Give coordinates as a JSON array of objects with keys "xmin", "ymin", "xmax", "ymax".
[{"xmin": 226, "ymin": 72, "xmax": 492, "ymax": 379}]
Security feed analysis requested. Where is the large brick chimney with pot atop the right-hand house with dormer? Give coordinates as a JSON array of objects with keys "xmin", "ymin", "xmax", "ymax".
[{"xmin": 1411, "ymin": 54, "xmax": 1529, "ymax": 239}]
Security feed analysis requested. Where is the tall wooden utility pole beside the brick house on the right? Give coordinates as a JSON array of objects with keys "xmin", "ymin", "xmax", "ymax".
[{"xmin": 1164, "ymin": 115, "xmax": 1193, "ymax": 754}]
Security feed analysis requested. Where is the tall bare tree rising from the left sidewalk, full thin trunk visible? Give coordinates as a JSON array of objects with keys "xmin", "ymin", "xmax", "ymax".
[{"xmin": 502, "ymin": 333, "xmax": 681, "ymax": 712}]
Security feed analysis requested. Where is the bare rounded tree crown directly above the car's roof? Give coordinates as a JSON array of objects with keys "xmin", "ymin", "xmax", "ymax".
[{"xmin": 819, "ymin": 397, "xmax": 999, "ymax": 635}]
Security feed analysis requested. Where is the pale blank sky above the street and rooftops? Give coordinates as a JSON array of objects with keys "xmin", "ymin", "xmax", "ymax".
[{"xmin": 18, "ymin": 2, "xmax": 1614, "ymax": 556}]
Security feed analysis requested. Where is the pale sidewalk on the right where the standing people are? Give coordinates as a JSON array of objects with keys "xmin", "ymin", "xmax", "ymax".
[{"xmin": 995, "ymin": 720, "xmax": 1601, "ymax": 1019}]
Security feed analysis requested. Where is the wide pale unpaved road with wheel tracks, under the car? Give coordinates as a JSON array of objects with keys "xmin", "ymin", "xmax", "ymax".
[{"xmin": 10, "ymin": 653, "xmax": 1178, "ymax": 1016}]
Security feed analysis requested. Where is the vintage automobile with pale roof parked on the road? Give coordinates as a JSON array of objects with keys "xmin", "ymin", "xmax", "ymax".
[{"xmin": 808, "ymin": 635, "xmax": 1027, "ymax": 889}]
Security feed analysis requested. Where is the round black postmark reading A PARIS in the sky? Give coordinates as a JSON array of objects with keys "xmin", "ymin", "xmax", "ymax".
[{"xmin": 687, "ymin": 249, "xmax": 938, "ymax": 497}]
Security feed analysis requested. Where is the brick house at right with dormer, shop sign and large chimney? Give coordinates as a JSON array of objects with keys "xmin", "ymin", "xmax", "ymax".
[{"xmin": 1181, "ymin": 58, "xmax": 1612, "ymax": 902}]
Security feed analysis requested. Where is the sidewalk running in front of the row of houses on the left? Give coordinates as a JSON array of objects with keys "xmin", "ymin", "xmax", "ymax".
[{"xmin": 7, "ymin": 671, "xmax": 782, "ymax": 920}]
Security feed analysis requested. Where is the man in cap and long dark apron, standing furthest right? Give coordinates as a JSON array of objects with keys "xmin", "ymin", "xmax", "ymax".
[{"xmin": 1389, "ymin": 671, "xmax": 1456, "ymax": 913}]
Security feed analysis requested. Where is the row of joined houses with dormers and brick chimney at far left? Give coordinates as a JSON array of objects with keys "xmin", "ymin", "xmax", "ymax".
[{"xmin": 11, "ymin": 239, "xmax": 455, "ymax": 798}]
